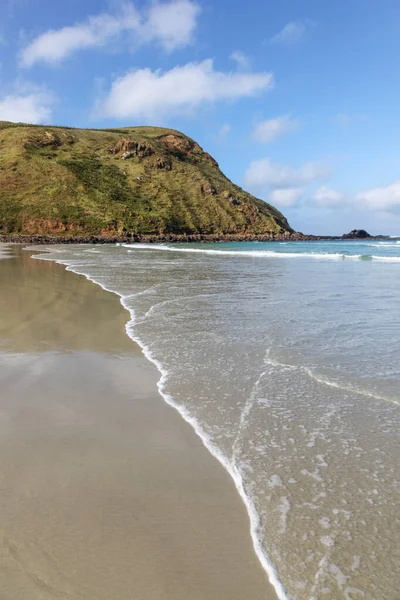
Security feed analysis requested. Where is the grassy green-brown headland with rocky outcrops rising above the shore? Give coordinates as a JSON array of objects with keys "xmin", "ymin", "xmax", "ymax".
[{"xmin": 0, "ymin": 122, "xmax": 292, "ymax": 237}]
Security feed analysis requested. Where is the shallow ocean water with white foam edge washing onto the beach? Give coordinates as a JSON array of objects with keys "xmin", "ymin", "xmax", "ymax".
[{"xmin": 33, "ymin": 240, "xmax": 400, "ymax": 600}]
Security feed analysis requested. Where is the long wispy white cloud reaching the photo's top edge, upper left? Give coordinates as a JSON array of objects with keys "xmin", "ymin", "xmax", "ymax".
[{"xmin": 21, "ymin": 0, "xmax": 200, "ymax": 67}]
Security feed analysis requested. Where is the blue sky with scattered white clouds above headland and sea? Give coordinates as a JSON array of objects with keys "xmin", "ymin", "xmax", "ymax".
[{"xmin": 0, "ymin": 0, "xmax": 400, "ymax": 235}]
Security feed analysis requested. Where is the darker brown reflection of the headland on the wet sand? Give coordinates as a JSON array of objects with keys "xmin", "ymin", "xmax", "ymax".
[{"xmin": 0, "ymin": 246, "xmax": 136, "ymax": 354}]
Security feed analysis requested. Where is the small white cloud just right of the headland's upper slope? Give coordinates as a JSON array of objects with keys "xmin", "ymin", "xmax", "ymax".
[{"xmin": 245, "ymin": 158, "xmax": 331, "ymax": 188}]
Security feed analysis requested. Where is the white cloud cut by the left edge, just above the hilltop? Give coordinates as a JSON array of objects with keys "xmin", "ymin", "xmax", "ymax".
[{"xmin": 0, "ymin": 92, "xmax": 52, "ymax": 124}]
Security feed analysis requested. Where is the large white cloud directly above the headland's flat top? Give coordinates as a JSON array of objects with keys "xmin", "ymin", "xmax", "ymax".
[{"xmin": 101, "ymin": 60, "xmax": 273, "ymax": 122}]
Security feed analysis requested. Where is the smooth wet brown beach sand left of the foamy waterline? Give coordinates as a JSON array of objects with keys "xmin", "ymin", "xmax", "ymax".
[{"xmin": 0, "ymin": 246, "xmax": 276, "ymax": 600}]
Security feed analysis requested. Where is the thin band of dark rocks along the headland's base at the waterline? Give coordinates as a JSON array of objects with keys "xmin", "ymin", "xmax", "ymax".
[{"xmin": 0, "ymin": 232, "xmax": 391, "ymax": 245}]
